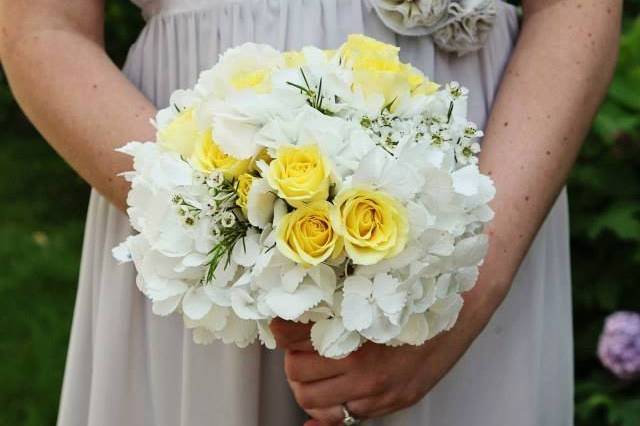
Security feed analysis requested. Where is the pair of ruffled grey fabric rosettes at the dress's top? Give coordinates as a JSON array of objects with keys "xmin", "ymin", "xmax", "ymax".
[{"xmin": 370, "ymin": 0, "xmax": 497, "ymax": 55}]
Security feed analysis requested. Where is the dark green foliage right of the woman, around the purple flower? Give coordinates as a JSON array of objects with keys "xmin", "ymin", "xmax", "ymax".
[{"xmin": 569, "ymin": 4, "xmax": 640, "ymax": 426}]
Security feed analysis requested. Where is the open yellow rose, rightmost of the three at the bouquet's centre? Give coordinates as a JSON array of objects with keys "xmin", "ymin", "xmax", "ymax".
[{"xmin": 331, "ymin": 188, "xmax": 409, "ymax": 265}]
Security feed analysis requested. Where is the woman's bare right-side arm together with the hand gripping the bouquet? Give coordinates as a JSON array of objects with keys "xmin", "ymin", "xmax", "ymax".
[{"xmin": 271, "ymin": 0, "xmax": 622, "ymax": 426}]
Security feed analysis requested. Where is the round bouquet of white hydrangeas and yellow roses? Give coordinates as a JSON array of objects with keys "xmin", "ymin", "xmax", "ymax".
[{"xmin": 113, "ymin": 35, "xmax": 495, "ymax": 358}]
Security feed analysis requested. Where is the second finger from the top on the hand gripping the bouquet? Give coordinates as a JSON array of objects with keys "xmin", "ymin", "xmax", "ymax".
[{"xmin": 284, "ymin": 350, "xmax": 352, "ymax": 383}]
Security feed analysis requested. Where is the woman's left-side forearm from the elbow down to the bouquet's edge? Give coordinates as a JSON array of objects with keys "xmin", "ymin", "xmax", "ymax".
[{"xmin": 2, "ymin": 19, "xmax": 155, "ymax": 209}]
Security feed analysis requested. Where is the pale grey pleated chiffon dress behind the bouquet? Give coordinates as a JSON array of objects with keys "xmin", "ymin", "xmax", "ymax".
[{"xmin": 58, "ymin": 0, "xmax": 573, "ymax": 426}]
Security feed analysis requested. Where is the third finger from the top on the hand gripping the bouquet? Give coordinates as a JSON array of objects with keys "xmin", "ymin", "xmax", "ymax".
[{"xmin": 289, "ymin": 374, "xmax": 384, "ymax": 410}]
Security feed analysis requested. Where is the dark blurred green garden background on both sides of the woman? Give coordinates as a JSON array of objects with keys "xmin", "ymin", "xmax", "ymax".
[{"xmin": 0, "ymin": 0, "xmax": 640, "ymax": 426}]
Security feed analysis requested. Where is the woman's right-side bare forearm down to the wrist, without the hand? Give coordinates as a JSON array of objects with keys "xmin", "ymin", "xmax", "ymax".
[{"xmin": 461, "ymin": 0, "xmax": 622, "ymax": 334}]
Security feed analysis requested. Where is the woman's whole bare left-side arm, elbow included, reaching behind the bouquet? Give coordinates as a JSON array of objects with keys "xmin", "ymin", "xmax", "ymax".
[{"xmin": 0, "ymin": 0, "xmax": 156, "ymax": 211}]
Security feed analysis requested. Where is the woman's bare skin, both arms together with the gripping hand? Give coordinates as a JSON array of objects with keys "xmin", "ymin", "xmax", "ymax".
[{"xmin": 0, "ymin": 0, "xmax": 622, "ymax": 426}]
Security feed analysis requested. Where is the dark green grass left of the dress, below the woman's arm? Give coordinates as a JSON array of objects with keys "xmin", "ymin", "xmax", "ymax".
[{"xmin": 0, "ymin": 135, "xmax": 88, "ymax": 426}]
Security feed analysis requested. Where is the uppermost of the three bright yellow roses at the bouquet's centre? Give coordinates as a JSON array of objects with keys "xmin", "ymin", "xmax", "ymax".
[{"xmin": 266, "ymin": 145, "xmax": 331, "ymax": 207}]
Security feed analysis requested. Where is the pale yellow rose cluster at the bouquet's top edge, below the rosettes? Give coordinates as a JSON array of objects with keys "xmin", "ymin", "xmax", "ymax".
[{"xmin": 341, "ymin": 34, "xmax": 439, "ymax": 104}]
